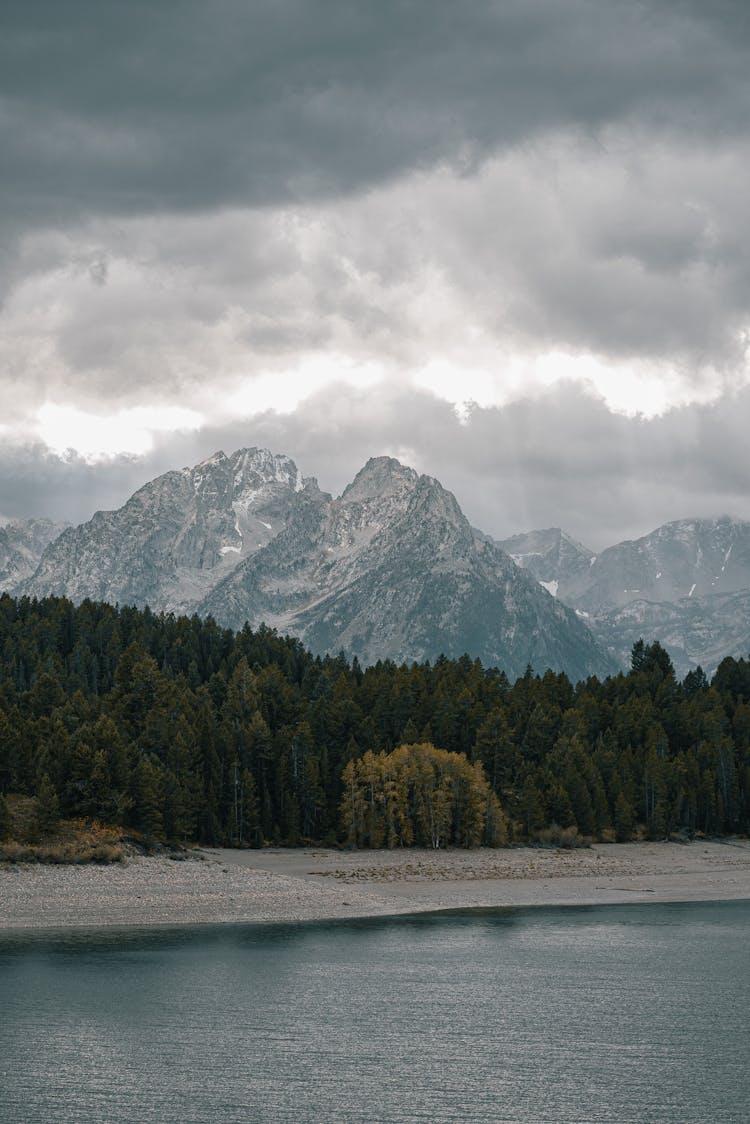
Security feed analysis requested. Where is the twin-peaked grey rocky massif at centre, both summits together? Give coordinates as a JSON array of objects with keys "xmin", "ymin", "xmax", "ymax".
[{"xmin": 17, "ymin": 448, "xmax": 613, "ymax": 679}]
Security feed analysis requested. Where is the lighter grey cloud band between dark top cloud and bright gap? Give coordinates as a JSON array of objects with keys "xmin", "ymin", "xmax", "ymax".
[{"xmin": 4, "ymin": 133, "xmax": 750, "ymax": 424}]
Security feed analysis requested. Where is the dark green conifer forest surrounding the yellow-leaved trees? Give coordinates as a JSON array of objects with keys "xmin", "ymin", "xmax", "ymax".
[{"xmin": 0, "ymin": 596, "xmax": 750, "ymax": 845}]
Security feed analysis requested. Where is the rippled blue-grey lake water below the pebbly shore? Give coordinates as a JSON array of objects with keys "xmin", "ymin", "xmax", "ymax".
[{"xmin": 0, "ymin": 901, "xmax": 750, "ymax": 1124}]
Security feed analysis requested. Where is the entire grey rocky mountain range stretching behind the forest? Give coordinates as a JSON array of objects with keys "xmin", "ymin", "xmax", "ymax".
[{"xmin": 5, "ymin": 448, "xmax": 750, "ymax": 679}]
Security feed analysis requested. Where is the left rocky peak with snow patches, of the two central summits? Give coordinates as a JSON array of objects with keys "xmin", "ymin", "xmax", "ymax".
[{"xmin": 25, "ymin": 448, "xmax": 304, "ymax": 613}]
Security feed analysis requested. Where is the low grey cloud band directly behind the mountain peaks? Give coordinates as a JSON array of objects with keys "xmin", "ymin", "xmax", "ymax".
[{"xmin": 5, "ymin": 387, "xmax": 750, "ymax": 550}]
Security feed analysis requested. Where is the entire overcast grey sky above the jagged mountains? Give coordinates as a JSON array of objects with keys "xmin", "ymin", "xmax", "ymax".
[{"xmin": 0, "ymin": 0, "xmax": 750, "ymax": 549}]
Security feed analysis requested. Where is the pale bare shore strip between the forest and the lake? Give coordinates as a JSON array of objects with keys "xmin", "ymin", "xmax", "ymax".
[{"xmin": 0, "ymin": 841, "xmax": 750, "ymax": 930}]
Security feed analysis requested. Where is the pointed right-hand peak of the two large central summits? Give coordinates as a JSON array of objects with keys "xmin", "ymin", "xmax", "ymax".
[{"xmin": 199, "ymin": 457, "xmax": 607, "ymax": 678}]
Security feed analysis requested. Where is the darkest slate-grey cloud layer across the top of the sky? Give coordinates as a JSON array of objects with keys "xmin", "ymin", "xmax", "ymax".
[{"xmin": 0, "ymin": 0, "xmax": 750, "ymax": 234}]
